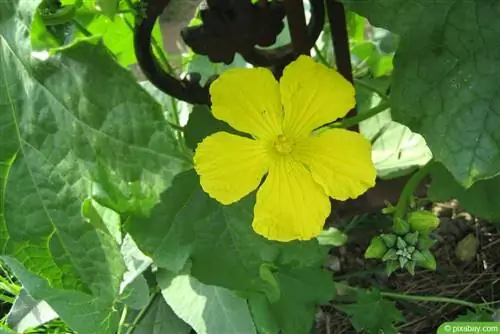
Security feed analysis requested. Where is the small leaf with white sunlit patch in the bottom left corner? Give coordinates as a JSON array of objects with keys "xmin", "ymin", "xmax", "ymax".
[{"xmin": 6, "ymin": 289, "xmax": 58, "ymax": 333}]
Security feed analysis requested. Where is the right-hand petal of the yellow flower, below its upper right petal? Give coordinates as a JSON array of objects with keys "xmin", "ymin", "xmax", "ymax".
[{"xmin": 294, "ymin": 129, "xmax": 377, "ymax": 201}]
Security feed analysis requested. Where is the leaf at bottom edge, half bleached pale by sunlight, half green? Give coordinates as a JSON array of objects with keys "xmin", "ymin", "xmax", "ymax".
[{"xmin": 157, "ymin": 270, "xmax": 257, "ymax": 334}]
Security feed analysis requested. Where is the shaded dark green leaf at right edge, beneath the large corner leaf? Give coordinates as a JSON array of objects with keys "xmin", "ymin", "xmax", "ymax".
[{"xmin": 427, "ymin": 164, "xmax": 500, "ymax": 223}]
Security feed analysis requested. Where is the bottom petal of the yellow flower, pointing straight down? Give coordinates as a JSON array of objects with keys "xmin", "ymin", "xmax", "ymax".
[{"xmin": 252, "ymin": 157, "xmax": 330, "ymax": 241}]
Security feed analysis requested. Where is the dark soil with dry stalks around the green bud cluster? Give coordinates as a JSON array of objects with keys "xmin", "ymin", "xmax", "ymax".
[{"xmin": 315, "ymin": 202, "xmax": 500, "ymax": 334}]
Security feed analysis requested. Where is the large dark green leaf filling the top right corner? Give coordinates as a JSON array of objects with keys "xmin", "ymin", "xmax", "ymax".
[{"xmin": 343, "ymin": 0, "xmax": 500, "ymax": 187}]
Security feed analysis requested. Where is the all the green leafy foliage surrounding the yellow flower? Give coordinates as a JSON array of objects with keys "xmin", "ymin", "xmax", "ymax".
[{"xmin": 0, "ymin": 0, "xmax": 500, "ymax": 334}]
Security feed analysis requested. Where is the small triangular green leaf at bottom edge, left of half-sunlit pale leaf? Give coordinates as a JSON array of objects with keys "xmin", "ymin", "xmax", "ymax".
[{"xmin": 132, "ymin": 294, "xmax": 191, "ymax": 334}]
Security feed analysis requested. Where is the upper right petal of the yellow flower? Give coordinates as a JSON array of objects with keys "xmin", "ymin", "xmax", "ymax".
[{"xmin": 280, "ymin": 56, "xmax": 356, "ymax": 136}]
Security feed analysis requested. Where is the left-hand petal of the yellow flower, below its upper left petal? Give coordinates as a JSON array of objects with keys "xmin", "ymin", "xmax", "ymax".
[{"xmin": 194, "ymin": 132, "xmax": 269, "ymax": 204}]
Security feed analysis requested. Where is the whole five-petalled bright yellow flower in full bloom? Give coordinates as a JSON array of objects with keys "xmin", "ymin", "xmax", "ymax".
[{"xmin": 194, "ymin": 56, "xmax": 376, "ymax": 241}]
